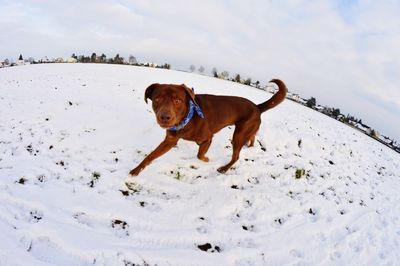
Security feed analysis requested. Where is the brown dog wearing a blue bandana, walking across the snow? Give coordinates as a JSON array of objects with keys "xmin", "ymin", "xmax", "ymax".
[{"xmin": 130, "ymin": 79, "xmax": 287, "ymax": 176}]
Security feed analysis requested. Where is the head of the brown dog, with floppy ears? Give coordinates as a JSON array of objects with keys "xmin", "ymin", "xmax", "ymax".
[{"xmin": 144, "ymin": 83, "xmax": 197, "ymax": 128}]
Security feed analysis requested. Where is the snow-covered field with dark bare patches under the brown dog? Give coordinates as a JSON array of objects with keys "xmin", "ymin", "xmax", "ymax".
[{"xmin": 0, "ymin": 64, "xmax": 400, "ymax": 265}]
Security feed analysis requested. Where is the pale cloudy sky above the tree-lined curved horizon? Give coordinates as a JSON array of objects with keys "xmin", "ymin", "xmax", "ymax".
[{"xmin": 0, "ymin": 0, "xmax": 400, "ymax": 142}]
